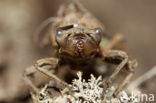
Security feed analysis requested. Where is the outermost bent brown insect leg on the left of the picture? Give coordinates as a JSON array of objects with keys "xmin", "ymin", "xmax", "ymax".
[{"xmin": 24, "ymin": 58, "xmax": 58, "ymax": 94}]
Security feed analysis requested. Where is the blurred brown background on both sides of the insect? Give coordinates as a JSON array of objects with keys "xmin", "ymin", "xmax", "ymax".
[{"xmin": 0, "ymin": 0, "xmax": 156, "ymax": 103}]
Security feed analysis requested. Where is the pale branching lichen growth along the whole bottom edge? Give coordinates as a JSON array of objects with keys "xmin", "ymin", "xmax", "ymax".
[{"xmin": 32, "ymin": 72, "xmax": 139, "ymax": 103}]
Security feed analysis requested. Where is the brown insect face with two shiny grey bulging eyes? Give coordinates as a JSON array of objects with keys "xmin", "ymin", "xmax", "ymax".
[{"xmin": 56, "ymin": 25, "xmax": 102, "ymax": 58}]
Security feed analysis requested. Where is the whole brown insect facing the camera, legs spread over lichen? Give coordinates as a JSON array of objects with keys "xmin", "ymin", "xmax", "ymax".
[{"xmin": 24, "ymin": 2, "xmax": 135, "ymax": 96}]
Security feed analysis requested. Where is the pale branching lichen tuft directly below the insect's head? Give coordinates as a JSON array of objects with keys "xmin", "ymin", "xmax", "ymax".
[{"xmin": 70, "ymin": 72, "xmax": 103, "ymax": 103}]
